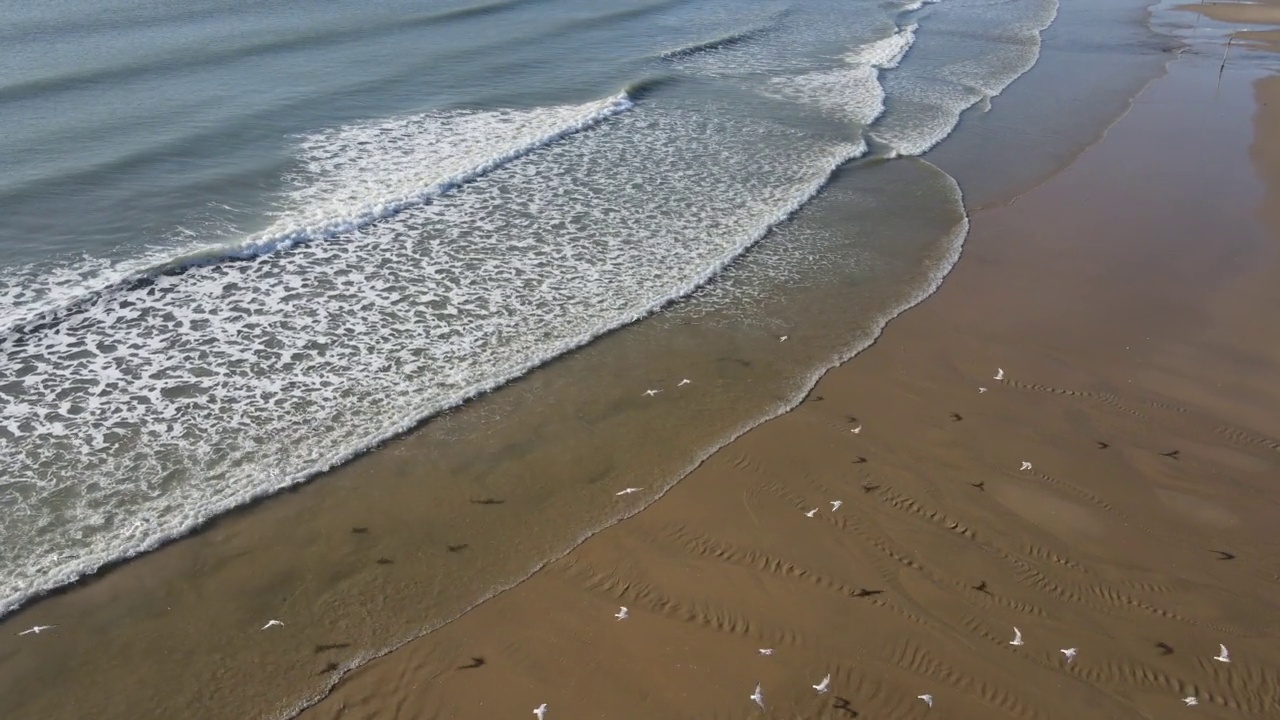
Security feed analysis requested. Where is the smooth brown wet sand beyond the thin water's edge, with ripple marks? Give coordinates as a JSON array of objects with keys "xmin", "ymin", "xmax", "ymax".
[{"xmin": 290, "ymin": 29, "xmax": 1280, "ymax": 720}]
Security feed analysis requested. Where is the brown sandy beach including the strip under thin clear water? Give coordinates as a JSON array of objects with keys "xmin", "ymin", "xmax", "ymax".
[{"xmin": 0, "ymin": 0, "xmax": 1280, "ymax": 720}]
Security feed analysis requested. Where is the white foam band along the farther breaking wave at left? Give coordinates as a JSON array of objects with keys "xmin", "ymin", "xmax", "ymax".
[{"xmin": 0, "ymin": 94, "xmax": 634, "ymax": 333}]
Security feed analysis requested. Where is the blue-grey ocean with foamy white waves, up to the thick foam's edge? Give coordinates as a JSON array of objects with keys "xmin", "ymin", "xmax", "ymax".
[{"xmin": 0, "ymin": 0, "xmax": 1057, "ymax": 612}]
